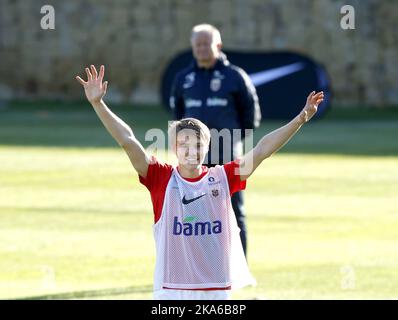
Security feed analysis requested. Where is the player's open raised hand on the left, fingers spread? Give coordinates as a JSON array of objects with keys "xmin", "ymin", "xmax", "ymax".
[{"xmin": 76, "ymin": 65, "xmax": 108, "ymax": 104}]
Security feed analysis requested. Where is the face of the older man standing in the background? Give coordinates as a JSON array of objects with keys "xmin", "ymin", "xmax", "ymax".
[{"xmin": 191, "ymin": 31, "xmax": 221, "ymax": 64}]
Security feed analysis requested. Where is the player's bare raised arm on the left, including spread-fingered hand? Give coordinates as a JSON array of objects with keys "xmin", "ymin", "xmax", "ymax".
[{"xmin": 76, "ymin": 65, "xmax": 149, "ymax": 178}]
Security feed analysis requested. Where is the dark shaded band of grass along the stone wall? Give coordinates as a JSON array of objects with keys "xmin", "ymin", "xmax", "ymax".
[{"xmin": 0, "ymin": 102, "xmax": 398, "ymax": 156}]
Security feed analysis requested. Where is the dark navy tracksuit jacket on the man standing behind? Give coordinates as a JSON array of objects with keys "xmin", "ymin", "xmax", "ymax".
[{"xmin": 170, "ymin": 54, "xmax": 261, "ymax": 164}]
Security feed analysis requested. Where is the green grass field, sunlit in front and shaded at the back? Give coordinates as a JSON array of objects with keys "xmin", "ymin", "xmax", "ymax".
[{"xmin": 0, "ymin": 102, "xmax": 398, "ymax": 299}]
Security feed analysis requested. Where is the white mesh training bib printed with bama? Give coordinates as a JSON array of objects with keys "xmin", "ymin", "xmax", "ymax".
[{"xmin": 153, "ymin": 166, "xmax": 255, "ymax": 290}]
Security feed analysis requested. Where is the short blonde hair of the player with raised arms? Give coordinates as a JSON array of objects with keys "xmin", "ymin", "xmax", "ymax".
[{"xmin": 167, "ymin": 118, "xmax": 210, "ymax": 150}]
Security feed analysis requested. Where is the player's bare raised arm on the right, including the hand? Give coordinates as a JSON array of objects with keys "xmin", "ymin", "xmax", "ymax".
[{"xmin": 239, "ymin": 91, "xmax": 323, "ymax": 180}]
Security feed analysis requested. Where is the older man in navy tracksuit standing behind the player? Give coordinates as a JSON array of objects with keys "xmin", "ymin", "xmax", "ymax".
[{"xmin": 170, "ymin": 24, "xmax": 261, "ymax": 255}]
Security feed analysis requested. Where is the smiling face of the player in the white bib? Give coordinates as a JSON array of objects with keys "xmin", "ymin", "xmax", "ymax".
[{"xmin": 176, "ymin": 129, "xmax": 208, "ymax": 169}]
